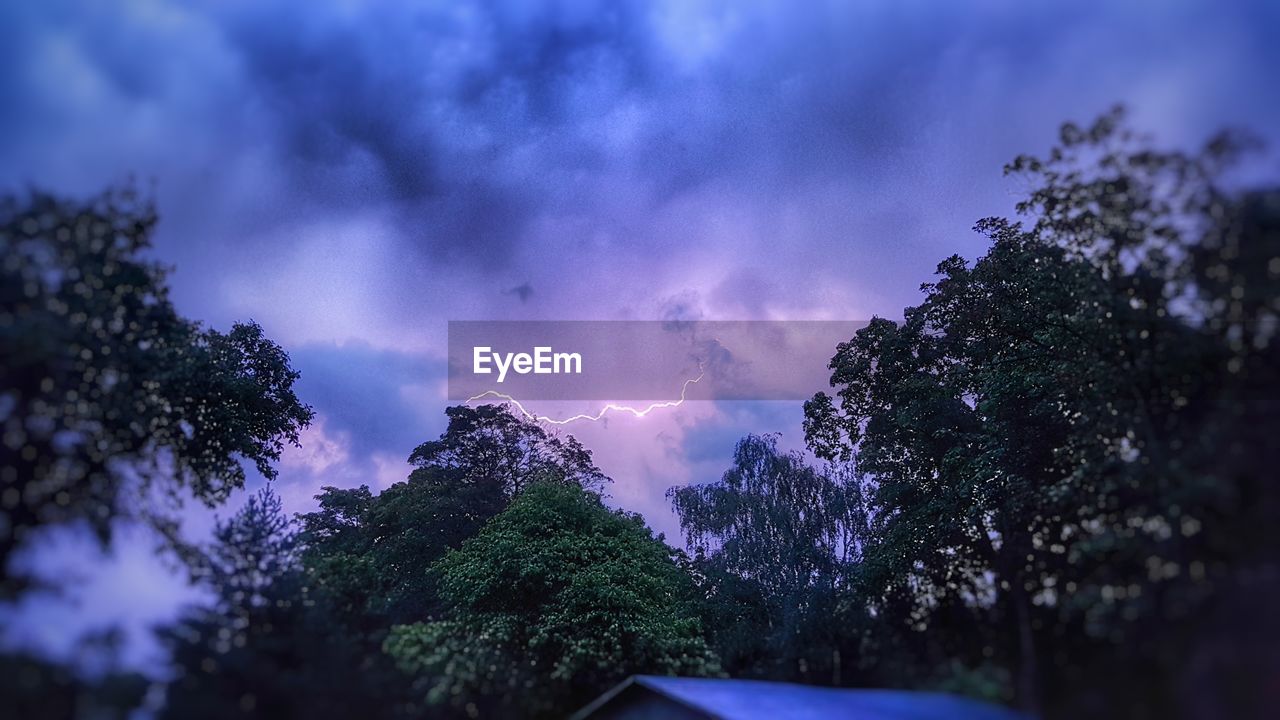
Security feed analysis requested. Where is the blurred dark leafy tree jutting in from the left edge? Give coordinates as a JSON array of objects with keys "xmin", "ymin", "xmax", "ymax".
[{"xmin": 0, "ymin": 184, "xmax": 312, "ymax": 596}]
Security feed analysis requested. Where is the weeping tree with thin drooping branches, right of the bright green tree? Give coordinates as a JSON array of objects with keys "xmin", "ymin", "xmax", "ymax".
[{"xmin": 667, "ymin": 436, "xmax": 865, "ymax": 684}]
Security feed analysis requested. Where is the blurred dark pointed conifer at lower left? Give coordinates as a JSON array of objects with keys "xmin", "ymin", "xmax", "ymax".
[{"xmin": 159, "ymin": 481, "xmax": 416, "ymax": 720}]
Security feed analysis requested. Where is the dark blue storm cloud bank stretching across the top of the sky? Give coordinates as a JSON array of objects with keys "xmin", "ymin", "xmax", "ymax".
[{"xmin": 0, "ymin": 1, "xmax": 1276, "ymax": 283}]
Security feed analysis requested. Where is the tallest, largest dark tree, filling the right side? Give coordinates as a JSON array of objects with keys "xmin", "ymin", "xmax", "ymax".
[{"xmin": 805, "ymin": 111, "xmax": 1280, "ymax": 717}]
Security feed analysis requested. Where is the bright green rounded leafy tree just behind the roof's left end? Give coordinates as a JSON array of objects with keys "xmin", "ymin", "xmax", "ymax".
[{"xmin": 387, "ymin": 482, "xmax": 718, "ymax": 717}]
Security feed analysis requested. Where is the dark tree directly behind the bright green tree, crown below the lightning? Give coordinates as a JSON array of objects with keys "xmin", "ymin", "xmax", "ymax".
[{"xmin": 291, "ymin": 406, "xmax": 608, "ymax": 716}]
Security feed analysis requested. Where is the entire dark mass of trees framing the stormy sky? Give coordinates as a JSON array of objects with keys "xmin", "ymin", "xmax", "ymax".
[{"xmin": 10, "ymin": 111, "xmax": 1280, "ymax": 720}]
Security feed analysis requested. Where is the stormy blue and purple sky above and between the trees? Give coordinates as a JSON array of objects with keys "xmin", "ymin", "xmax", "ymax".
[{"xmin": 0, "ymin": 0, "xmax": 1280, "ymax": 671}]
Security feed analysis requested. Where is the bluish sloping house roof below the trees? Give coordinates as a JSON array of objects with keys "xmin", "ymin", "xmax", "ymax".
[{"xmin": 571, "ymin": 675, "xmax": 1025, "ymax": 720}]
